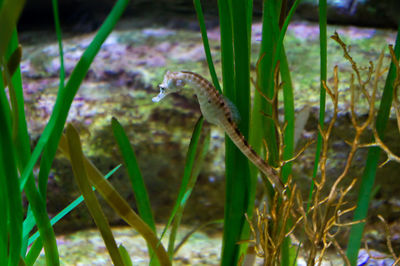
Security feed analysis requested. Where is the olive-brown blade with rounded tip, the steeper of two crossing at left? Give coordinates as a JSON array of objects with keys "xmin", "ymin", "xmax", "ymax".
[{"xmin": 66, "ymin": 124, "xmax": 124, "ymax": 266}]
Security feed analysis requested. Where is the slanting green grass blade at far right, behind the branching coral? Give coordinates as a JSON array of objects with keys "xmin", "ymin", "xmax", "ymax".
[{"xmin": 346, "ymin": 22, "xmax": 400, "ymax": 265}]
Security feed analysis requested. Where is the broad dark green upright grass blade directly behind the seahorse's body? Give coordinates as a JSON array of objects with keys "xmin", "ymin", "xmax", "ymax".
[{"xmin": 219, "ymin": 0, "xmax": 254, "ymax": 265}]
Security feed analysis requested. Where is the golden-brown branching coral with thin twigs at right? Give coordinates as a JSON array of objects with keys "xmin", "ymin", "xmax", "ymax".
[{"xmin": 245, "ymin": 33, "xmax": 400, "ymax": 265}]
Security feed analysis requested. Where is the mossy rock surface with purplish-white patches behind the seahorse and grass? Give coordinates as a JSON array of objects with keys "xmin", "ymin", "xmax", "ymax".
[{"xmin": 21, "ymin": 17, "xmax": 400, "ymax": 243}]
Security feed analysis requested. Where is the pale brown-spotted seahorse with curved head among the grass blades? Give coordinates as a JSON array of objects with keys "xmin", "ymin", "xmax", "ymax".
[{"xmin": 152, "ymin": 71, "xmax": 284, "ymax": 193}]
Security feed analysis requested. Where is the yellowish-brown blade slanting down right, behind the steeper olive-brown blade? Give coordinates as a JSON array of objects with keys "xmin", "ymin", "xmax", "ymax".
[{"xmin": 59, "ymin": 135, "xmax": 171, "ymax": 266}]
